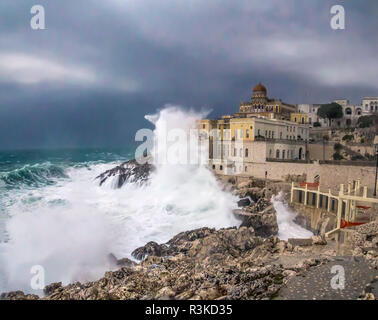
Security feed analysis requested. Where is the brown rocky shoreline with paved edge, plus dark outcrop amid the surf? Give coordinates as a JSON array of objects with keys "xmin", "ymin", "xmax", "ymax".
[{"xmin": 1, "ymin": 162, "xmax": 378, "ymax": 300}]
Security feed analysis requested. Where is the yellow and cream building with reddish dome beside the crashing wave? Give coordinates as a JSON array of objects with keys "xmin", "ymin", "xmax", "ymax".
[{"xmin": 200, "ymin": 84, "xmax": 309, "ymax": 174}]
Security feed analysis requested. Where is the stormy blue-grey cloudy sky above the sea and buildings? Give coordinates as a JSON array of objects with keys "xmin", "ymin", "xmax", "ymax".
[{"xmin": 0, "ymin": 0, "xmax": 378, "ymax": 149}]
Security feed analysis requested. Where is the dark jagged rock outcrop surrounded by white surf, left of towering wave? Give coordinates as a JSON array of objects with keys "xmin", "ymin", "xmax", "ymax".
[{"xmin": 96, "ymin": 160, "xmax": 154, "ymax": 188}]
